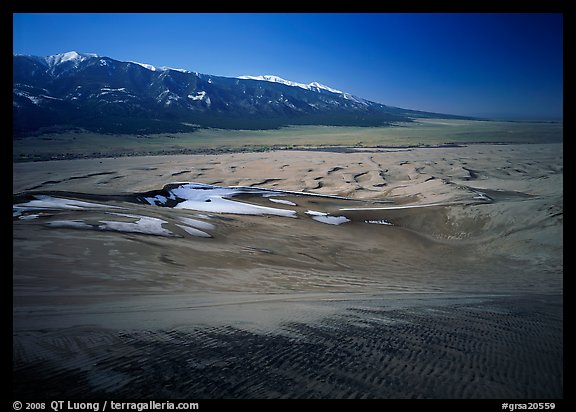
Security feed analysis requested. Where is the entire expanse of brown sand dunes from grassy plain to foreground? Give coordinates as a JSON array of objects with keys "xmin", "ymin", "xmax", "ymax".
[{"xmin": 13, "ymin": 144, "xmax": 563, "ymax": 398}]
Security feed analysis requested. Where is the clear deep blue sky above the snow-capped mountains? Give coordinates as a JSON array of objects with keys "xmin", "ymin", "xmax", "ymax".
[{"xmin": 13, "ymin": 13, "xmax": 563, "ymax": 118}]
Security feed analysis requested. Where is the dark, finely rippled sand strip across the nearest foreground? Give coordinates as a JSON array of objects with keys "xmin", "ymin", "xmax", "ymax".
[{"xmin": 14, "ymin": 295, "xmax": 563, "ymax": 399}]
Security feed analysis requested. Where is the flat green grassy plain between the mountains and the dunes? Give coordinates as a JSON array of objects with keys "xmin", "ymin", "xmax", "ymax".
[{"xmin": 13, "ymin": 119, "xmax": 563, "ymax": 161}]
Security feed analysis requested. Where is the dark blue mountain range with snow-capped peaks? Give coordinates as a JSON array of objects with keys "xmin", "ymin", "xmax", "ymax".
[{"xmin": 13, "ymin": 52, "xmax": 468, "ymax": 137}]
